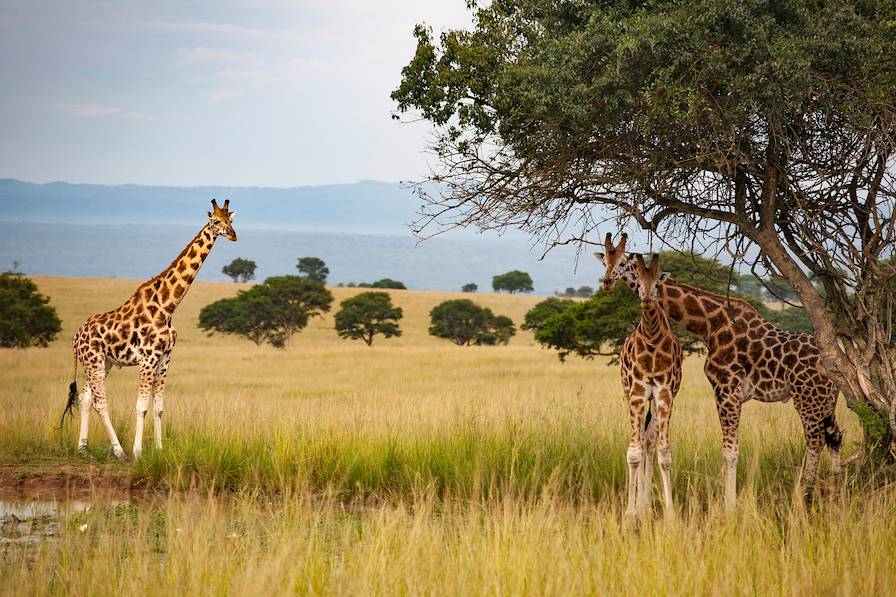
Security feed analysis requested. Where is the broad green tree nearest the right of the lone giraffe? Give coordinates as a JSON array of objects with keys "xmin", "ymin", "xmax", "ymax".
[{"xmin": 199, "ymin": 276, "xmax": 333, "ymax": 348}]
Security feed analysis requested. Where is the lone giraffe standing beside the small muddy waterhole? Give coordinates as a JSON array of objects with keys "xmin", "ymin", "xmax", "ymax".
[{"xmin": 62, "ymin": 199, "xmax": 236, "ymax": 460}]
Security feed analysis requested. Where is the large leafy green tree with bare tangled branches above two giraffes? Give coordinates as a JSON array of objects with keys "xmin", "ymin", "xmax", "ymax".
[{"xmin": 393, "ymin": 0, "xmax": 896, "ymax": 453}]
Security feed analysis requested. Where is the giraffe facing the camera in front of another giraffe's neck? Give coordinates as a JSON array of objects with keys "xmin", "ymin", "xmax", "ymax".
[{"xmin": 620, "ymin": 255, "xmax": 682, "ymax": 518}]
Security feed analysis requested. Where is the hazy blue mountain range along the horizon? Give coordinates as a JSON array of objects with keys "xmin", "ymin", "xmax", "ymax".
[{"xmin": 0, "ymin": 179, "xmax": 601, "ymax": 294}]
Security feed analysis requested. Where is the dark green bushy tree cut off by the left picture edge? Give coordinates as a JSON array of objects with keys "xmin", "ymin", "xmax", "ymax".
[{"xmin": 0, "ymin": 272, "xmax": 62, "ymax": 348}]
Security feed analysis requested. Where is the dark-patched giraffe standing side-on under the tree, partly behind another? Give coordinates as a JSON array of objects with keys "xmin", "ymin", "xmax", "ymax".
[{"xmin": 595, "ymin": 234, "xmax": 842, "ymax": 511}]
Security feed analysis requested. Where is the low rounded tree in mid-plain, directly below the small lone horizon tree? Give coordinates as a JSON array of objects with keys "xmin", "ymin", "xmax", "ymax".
[{"xmin": 429, "ymin": 299, "xmax": 516, "ymax": 346}]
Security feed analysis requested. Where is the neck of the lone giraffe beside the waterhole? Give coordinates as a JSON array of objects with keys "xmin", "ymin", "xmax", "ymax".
[{"xmin": 135, "ymin": 224, "xmax": 217, "ymax": 315}]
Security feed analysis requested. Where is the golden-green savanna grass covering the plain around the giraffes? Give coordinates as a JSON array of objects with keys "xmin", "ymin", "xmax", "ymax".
[{"xmin": 0, "ymin": 278, "xmax": 896, "ymax": 595}]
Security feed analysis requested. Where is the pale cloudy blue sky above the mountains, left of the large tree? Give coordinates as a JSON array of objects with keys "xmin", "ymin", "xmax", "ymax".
[{"xmin": 0, "ymin": 0, "xmax": 470, "ymax": 186}]
